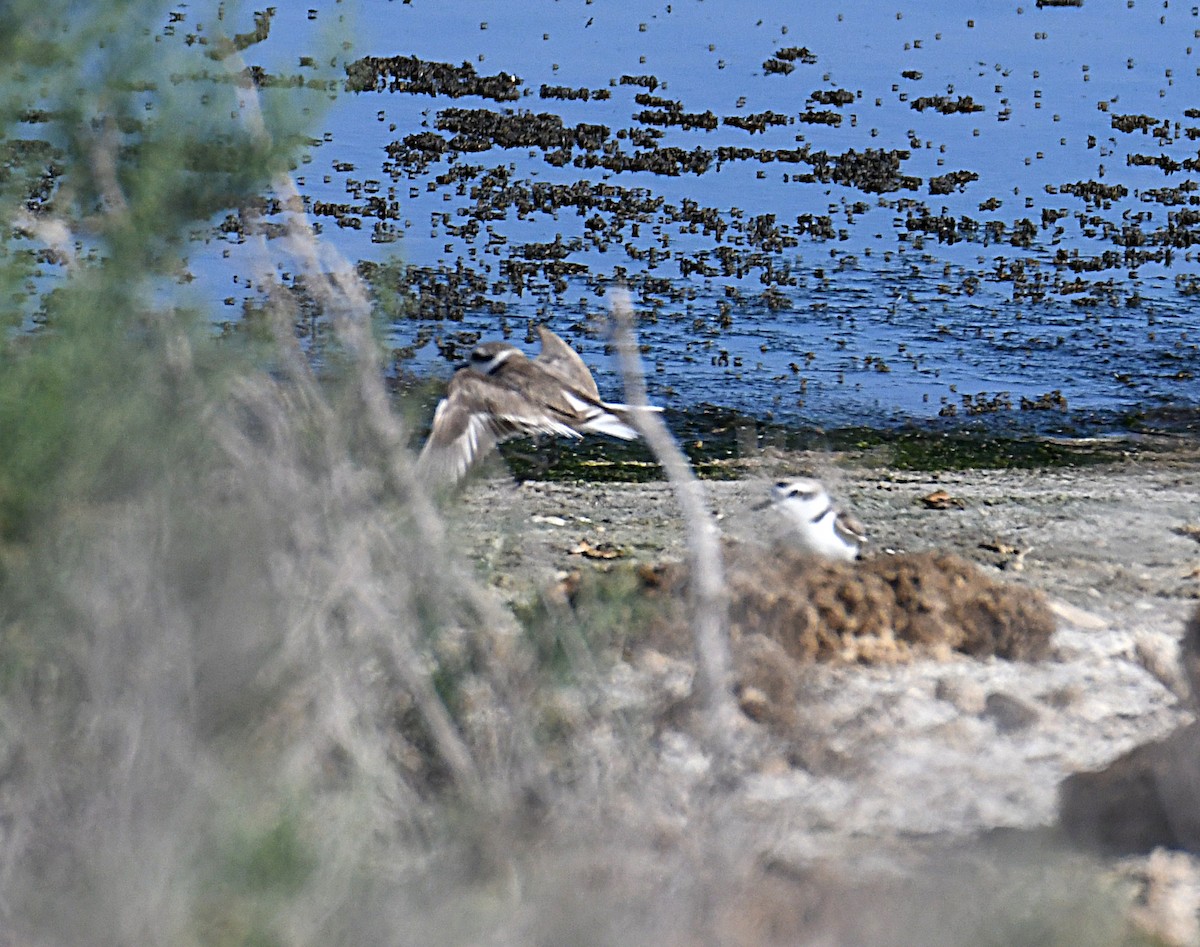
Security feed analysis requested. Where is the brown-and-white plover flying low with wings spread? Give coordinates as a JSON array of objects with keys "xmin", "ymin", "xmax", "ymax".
[{"xmin": 416, "ymin": 325, "xmax": 662, "ymax": 484}]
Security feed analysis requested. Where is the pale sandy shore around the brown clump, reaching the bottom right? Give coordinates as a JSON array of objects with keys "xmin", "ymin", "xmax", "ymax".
[{"xmin": 432, "ymin": 439, "xmax": 1200, "ymax": 943}]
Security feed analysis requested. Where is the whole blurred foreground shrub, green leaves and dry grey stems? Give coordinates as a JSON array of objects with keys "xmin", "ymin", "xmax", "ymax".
[{"xmin": 0, "ymin": 0, "xmax": 532, "ymax": 945}]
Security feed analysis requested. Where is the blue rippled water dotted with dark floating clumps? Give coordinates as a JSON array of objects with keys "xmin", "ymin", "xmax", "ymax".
[{"xmin": 201, "ymin": 0, "xmax": 1200, "ymax": 427}]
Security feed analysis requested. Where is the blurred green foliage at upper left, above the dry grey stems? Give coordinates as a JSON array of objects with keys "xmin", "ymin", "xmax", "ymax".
[{"xmin": 0, "ymin": 0, "xmax": 299, "ymax": 544}]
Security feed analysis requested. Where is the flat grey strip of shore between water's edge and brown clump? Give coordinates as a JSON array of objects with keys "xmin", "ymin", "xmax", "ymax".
[{"xmin": 451, "ymin": 443, "xmax": 1200, "ymax": 629}]
